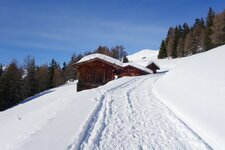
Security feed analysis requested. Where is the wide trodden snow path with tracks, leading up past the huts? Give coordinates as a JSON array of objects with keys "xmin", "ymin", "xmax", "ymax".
[{"xmin": 74, "ymin": 75, "xmax": 211, "ymax": 150}]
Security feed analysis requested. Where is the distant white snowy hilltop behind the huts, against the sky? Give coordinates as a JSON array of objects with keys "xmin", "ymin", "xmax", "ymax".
[{"xmin": 127, "ymin": 49, "xmax": 159, "ymax": 61}]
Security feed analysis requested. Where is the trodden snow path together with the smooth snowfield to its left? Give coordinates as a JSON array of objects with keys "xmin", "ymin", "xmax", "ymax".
[{"xmin": 0, "ymin": 75, "xmax": 211, "ymax": 150}]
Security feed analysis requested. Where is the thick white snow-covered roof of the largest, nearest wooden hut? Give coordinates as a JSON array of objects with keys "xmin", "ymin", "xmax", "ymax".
[{"xmin": 76, "ymin": 53, "xmax": 123, "ymax": 67}]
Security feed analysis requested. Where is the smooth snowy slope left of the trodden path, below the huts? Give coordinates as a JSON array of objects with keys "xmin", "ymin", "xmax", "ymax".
[{"xmin": 0, "ymin": 78, "xmax": 130, "ymax": 150}]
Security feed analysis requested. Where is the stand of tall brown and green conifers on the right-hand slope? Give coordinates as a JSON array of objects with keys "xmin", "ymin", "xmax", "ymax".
[{"xmin": 158, "ymin": 8, "xmax": 225, "ymax": 58}]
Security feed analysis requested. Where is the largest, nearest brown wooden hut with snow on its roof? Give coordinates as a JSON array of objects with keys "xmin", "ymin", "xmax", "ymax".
[{"xmin": 74, "ymin": 54, "xmax": 123, "ymax": 91}]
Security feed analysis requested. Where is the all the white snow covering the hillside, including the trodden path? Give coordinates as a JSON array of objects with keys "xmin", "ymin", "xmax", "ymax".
[{"xmin": 0, "ymin": 46, "xmax": 225, "ymax": 150}]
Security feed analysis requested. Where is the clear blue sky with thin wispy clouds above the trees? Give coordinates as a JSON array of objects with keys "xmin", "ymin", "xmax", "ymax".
[{"xmin": 0, "ymin": 0, "xmax": 225, "ymax": 65}]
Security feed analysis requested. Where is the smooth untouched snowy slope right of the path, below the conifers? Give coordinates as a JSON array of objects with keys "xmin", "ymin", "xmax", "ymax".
[{"xmin": 154, "ymin": 46, "xmax": 225, "ymax": 149}]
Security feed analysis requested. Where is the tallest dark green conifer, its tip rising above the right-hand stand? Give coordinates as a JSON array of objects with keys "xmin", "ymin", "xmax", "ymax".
[{"xmin": 203, "ymin": 7, "xmax": 215, "ymax": 51}]
